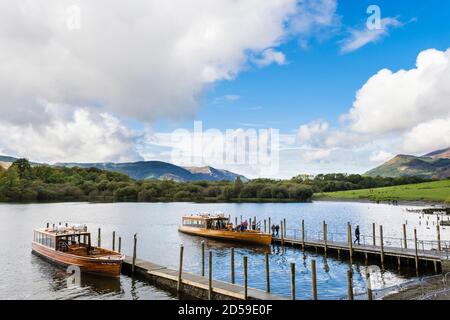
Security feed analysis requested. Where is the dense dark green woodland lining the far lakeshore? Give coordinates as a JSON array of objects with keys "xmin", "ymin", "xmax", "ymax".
[{"xmin": 0, "ymin": 159, "xmax": 427, "ymax": 202}]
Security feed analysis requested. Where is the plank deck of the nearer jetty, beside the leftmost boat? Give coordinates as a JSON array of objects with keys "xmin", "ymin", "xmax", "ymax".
[{"xmin": 122, "ymin": 256, "xmax": 288, "ymax": 300}]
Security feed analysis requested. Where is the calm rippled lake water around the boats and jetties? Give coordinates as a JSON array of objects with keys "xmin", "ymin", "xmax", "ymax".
[{"xmin": 0, "ymin": 202, "xmax": 450, "ymax": 299}]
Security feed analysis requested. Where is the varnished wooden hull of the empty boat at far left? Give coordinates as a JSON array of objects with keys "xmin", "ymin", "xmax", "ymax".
[{"xmin": 32, "ymin": 242, "xmax": 123, "ymax": 277}]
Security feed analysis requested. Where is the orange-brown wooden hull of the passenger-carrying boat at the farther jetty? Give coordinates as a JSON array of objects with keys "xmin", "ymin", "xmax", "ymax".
[{"xmin": 178, "ymin": 226, "xmax": 272, "ymax": 245}]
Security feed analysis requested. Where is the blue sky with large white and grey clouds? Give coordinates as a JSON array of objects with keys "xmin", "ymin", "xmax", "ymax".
[{"xmin": 0, "ymin": 0, "xmax": 450, "ymax": 178}]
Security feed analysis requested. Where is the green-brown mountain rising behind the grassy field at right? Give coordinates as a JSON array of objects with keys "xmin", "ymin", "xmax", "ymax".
[{"xmin": 365, "ymin": 148, "xmax": 450, "ymax": 179}]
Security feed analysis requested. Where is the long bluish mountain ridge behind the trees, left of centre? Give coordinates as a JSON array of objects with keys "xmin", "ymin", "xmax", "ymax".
[{"xmin": 55, "ymin": 161, "xmax": 248, "ymax": 181}]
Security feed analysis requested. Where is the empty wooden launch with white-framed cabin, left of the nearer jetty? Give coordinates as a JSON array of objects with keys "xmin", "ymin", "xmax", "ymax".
[{"xmin": 32, "ymin": 226, "xmax": 124, "ymax": 277}]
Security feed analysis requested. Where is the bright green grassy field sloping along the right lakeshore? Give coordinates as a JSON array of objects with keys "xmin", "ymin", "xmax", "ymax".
[{"xmin": 314, "ymin": 179, "xmax": 450, "ymax": 203}]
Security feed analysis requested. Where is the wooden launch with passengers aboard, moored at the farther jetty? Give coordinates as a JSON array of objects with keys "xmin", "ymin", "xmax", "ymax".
[{"xmin": 178, "ymin": 214, "xmax": 272, "ymax": 245}]
